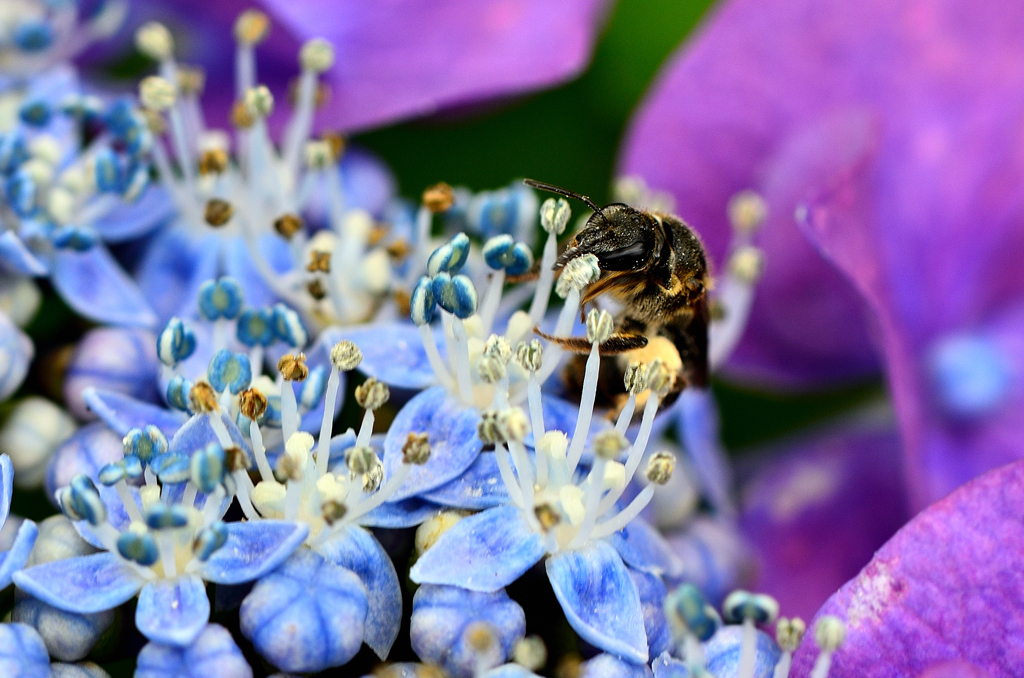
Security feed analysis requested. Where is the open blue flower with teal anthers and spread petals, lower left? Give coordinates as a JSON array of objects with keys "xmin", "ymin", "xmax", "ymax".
[{"xmin": 16, "ymin": 456, "xmax": 308, "ymax": 646}]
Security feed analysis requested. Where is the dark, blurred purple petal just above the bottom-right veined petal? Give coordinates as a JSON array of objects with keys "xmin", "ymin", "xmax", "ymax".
[{"xmin": 739, "ymin": 423, "xmax": 910, "ymax": 620}]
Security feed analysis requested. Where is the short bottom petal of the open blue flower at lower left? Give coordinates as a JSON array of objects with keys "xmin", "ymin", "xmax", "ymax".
[{"xmin": 135, "ymin": 575, "xmax": 210, "ymax": 646}]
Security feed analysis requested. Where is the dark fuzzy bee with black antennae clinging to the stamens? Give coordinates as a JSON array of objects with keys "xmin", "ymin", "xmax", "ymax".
[{"xmin": 525, "ymin": 179, "xmax": 711, "ymax": 410}]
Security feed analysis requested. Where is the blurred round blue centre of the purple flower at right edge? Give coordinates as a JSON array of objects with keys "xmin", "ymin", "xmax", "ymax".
[{"xmin": 928, "ymin": 334, "xmax": 1013, "ymax": 419}]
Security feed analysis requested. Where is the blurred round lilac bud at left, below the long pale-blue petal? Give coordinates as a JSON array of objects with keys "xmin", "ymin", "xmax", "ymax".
[{"xmin": 63, "ymin": 328, "xmax": 161, "ymax": 419}]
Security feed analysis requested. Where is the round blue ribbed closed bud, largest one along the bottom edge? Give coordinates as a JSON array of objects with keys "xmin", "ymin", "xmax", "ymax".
[{"xmin": 239, "ymin": 548, "xmax": 367, "ymax": 673}]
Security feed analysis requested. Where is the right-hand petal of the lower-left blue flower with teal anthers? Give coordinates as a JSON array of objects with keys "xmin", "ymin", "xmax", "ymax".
[{"xmin": 203, "ymin": 520, "xmax": 309, "ymax": 584}]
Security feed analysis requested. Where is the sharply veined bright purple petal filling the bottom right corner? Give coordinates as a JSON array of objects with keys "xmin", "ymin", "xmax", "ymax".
[{"xmin": 793, "ymin": 462, "xmax": 1024, "ymax": 678}]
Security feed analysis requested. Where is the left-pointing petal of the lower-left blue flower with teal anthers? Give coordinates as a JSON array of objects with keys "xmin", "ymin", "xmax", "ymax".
[{"xmin": 13, "ymin": 553, "xmax": 145, "ymax": 613}]
